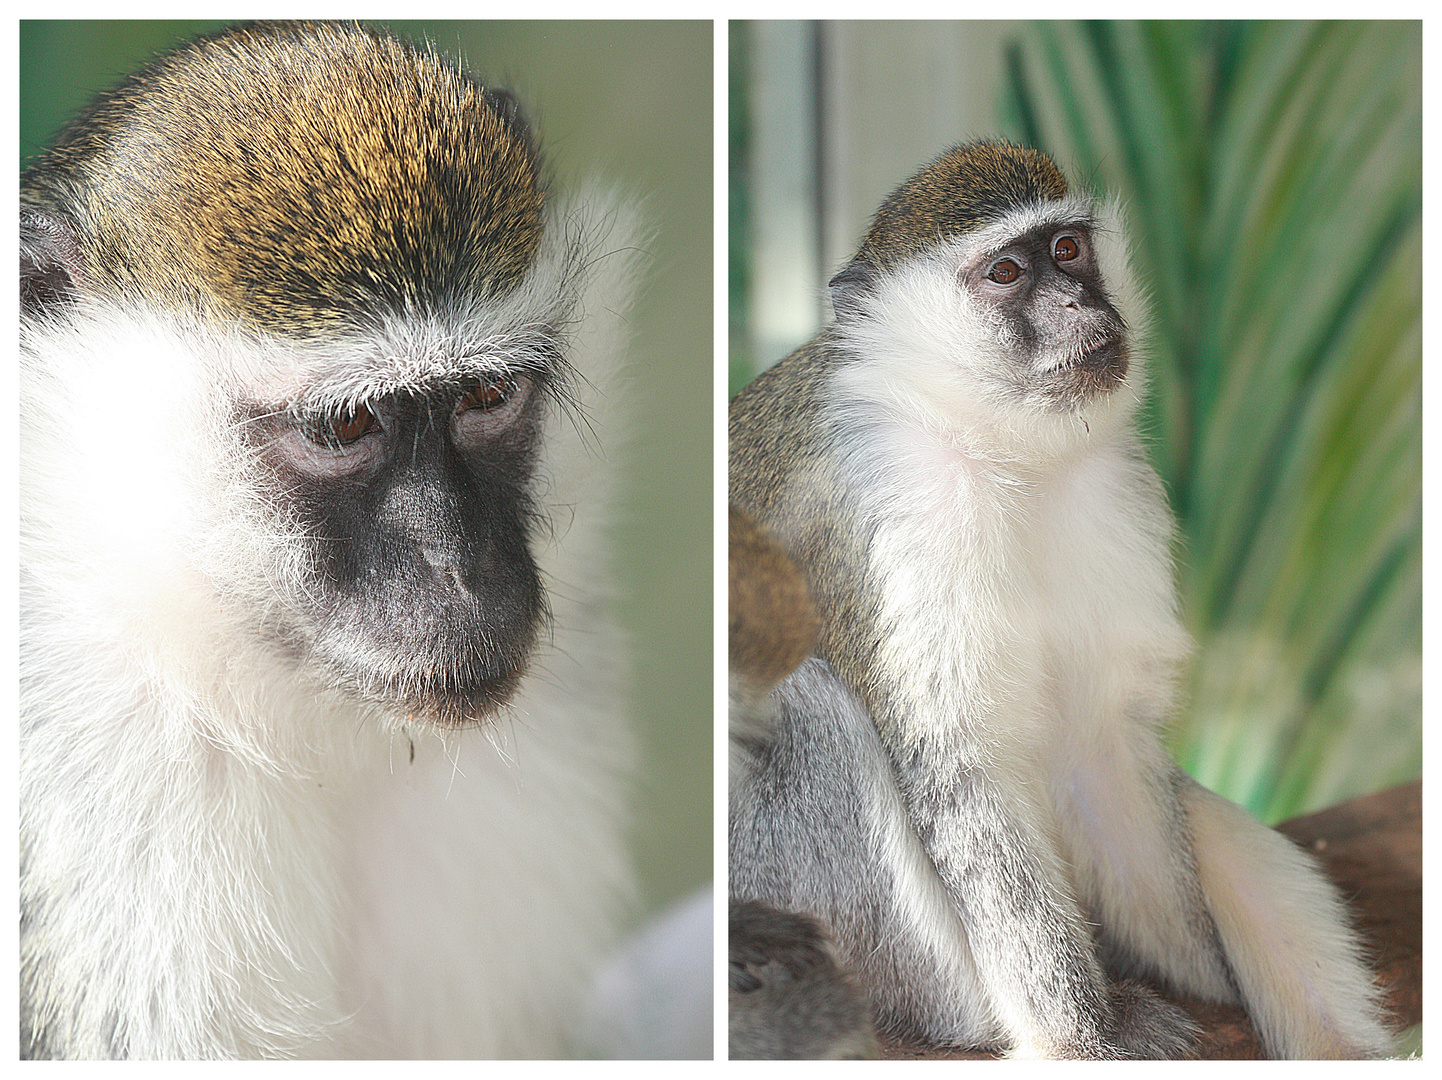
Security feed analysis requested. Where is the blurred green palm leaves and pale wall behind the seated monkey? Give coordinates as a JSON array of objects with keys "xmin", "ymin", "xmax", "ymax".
[{"xmin": 728, "ymin": 22, "xmax": 1422, "ymax": 822}]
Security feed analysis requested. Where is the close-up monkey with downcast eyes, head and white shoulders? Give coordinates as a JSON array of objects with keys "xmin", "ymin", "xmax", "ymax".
[{"xmin": 19, "ymin": 25, "xmax": 639, "ymax": 1058}]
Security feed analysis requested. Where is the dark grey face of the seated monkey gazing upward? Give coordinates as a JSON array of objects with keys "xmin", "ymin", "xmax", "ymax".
[{"xmin": 962, "ymin": 223, "xmax": 1128, "ymax": 407}]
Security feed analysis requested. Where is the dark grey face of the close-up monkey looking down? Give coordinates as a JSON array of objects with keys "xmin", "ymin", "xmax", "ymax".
[{"xmin": 254, "ymin": 366, "xmax": 545, "ymax": 725}]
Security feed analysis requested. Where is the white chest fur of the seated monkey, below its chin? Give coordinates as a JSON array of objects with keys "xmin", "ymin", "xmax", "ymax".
[{"xmin": 847, "ymin": 415, "xmax": 1188, "ymax": 767}]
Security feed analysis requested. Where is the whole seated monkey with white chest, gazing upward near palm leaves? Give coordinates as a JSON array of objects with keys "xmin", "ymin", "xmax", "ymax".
[{"xmin": 730, "ymin": 143, "xmax": 1389, "ymax": 1058}]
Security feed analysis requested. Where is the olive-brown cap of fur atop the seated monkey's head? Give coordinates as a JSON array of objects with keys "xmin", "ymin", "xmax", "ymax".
[{"xmin": 857, "ymin": 141, "xmax": 1067, "ymax": 270}]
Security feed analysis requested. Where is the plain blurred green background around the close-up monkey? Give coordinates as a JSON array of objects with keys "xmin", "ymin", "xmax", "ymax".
[{"xmin": 20, "ymin": 22, "xmax": 712, "ymax": 934}]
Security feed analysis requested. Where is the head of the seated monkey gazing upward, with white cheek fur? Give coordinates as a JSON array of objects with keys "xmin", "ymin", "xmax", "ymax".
[{"xmin": 831, "ymin": 141, "xmax": 1141, "ymax": 457}]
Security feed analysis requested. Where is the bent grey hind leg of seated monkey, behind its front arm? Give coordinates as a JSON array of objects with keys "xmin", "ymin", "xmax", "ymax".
[{"xmin": 730, "ymin": 658, "xmax": 1004, "ymax": 1047}]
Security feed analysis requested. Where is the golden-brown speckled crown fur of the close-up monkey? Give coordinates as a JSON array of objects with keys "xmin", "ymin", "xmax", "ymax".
[{"xmin": 22, "ymin": 23, "xmax": 545, "ymax": 333}]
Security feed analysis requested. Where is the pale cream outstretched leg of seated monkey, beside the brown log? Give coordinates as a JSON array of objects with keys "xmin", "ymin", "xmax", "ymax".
[{"xmin": 1182, "ymin": 782, "xmax": 1393, "ymax": 1058}]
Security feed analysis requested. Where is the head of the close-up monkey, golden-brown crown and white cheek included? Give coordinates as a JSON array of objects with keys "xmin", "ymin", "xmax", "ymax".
[{"xmin": 22, "ymin": 23, "xmax": 632, "ymax": 725}]
